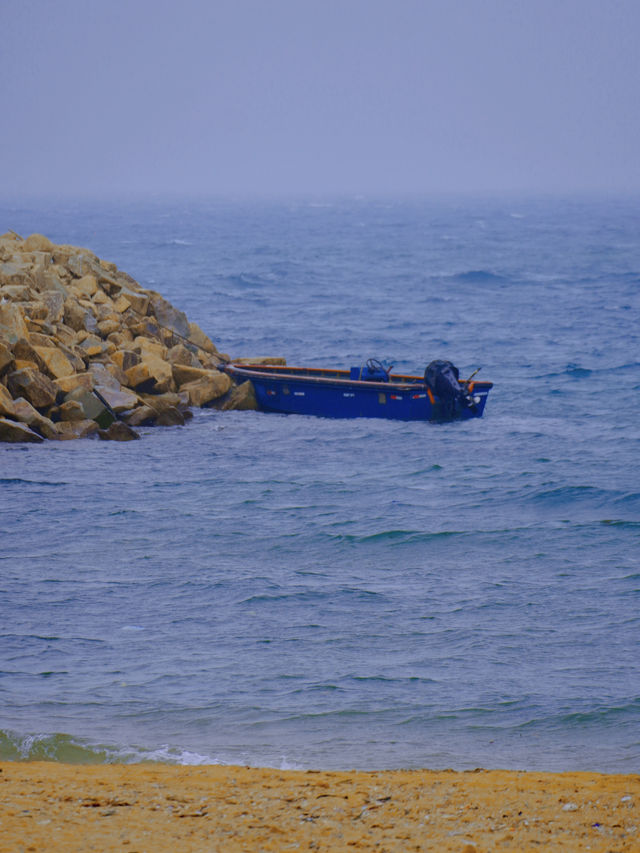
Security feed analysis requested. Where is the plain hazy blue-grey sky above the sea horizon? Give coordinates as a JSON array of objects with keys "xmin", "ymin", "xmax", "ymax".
[{"xmin": 0, "ymin": 0, "xmax": 640, "ymax": 194}]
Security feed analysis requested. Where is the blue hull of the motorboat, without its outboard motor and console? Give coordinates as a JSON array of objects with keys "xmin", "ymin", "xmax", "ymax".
[{"xmin": 224, "ymin": 364, "xmax": 492, "ymax": 421}]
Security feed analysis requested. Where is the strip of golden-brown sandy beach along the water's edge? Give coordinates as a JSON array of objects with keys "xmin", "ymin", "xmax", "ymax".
[{"xmin": 0, "ymin": 762, "xmax": 640, "ymax": 853}]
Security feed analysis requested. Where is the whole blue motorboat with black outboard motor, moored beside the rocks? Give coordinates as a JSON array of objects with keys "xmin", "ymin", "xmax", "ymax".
[{"xmin": 221, "ymin": 359, "xmax": 493, "ymax": 421}]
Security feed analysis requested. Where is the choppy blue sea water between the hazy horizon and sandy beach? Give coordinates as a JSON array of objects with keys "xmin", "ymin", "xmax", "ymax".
[{"xmin": 0, "ymin": 198, "xmax": 640, "ymax": 772}]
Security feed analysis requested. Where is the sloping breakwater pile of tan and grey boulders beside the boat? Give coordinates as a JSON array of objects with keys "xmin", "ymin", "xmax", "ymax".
[{"xmin": 0, "ymin": 232, "xmax": 262, "ymax": 442}]
